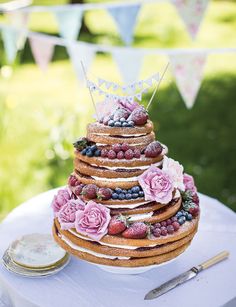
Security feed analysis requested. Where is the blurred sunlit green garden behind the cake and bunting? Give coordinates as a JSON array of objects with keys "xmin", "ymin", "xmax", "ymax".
[{"xmin": 0, "ymin": 0, "xmax": 236, "ymax": 219}]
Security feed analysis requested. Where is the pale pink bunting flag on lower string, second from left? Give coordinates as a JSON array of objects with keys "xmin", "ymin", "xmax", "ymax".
[{"xmin": 29, "ymin": 36, "xmax": 54, "ymax": 71}]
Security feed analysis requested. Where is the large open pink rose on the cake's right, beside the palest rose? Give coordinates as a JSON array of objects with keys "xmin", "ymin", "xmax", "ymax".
[{"xmin": 138, "ymin": 165, "xmax": 174, "ymax": 204}]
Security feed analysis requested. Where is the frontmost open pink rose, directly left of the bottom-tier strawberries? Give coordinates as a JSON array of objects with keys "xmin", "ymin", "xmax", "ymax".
[{"xmin": 75, "ymin": 200, "xmax": 111, "ymax": 241}]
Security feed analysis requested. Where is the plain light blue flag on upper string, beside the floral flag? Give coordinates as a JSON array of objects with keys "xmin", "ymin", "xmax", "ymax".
[{"xmin": 108, "ymin": 4, "xmax": 140, "ymax": 45}]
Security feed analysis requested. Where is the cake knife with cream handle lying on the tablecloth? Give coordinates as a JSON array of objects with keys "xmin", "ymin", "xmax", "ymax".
[{"xmin": 144, "ymin": 251, "xmax": 229, "ymax": 300}]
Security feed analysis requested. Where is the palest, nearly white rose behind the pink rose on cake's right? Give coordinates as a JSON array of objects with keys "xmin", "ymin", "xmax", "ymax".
[{"xmin": 162, "ymin": 156, "xmax": 184, "ymax": 190}]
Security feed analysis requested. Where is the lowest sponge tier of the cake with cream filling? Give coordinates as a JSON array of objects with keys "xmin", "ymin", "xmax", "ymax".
[{"xmin": 53, "ymin": 223, "xmax": 197, "ymax": 267}]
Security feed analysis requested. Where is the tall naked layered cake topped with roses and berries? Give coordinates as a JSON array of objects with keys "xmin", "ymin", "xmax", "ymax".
[{"xmin": 52, "ymin": 101, "xmax": 199, "ymax": 267}]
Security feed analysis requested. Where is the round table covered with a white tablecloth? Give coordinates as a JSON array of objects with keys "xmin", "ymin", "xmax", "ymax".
[{"xmin": 0, "ymin": 189, "xmax": 236, "ymax": 307}]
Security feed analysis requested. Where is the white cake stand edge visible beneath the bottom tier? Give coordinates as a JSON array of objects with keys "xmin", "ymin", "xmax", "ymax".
[{"xmin": 90, "ymin": 256, "xmax": 179, "ymax": 275}]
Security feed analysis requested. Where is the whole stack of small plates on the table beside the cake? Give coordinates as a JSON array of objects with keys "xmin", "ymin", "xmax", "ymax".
[{"xmin": 2, "ymin": 233, "xmax": 70, "ymax": 277}]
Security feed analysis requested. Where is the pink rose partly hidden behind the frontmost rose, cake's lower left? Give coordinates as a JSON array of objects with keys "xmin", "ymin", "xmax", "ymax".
[{"xmin": 58, "ymin": 198, "xmax": 85, "ymax": 230}]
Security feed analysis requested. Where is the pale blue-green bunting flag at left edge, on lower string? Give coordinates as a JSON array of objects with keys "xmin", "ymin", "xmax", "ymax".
[{"xmin": 2, "ymin": 27, "xmax": 19, "ymax": 63}]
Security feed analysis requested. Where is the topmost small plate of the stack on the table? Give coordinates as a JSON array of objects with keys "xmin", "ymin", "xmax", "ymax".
[{"xmin": 8, "ymin": 234, "xmax": 66, "ymax": 268}]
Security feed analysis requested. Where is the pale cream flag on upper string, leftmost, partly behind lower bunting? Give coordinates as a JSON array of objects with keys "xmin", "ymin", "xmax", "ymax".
[{"xmin": 7, "ymin": 11, "xmax": 29, "ymax": 50}]
